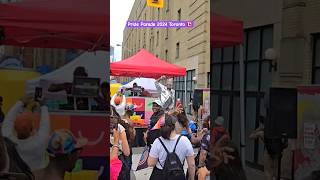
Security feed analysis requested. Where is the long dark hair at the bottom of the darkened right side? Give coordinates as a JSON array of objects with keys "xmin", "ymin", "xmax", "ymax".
[{"xmin": 207, "ymin": 142, "xmax": 247, "ymax": 180}]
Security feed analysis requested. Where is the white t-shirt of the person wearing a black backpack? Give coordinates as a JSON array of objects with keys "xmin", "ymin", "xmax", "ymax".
[{"xmin": 149, "ymin": 135, "xmax": 194, "ymax": 169}]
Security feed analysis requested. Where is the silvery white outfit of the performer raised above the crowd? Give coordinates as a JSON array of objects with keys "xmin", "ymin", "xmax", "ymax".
[{"xmin": 155, "ymin": 81, "xmax": 175, "ymax": 110}]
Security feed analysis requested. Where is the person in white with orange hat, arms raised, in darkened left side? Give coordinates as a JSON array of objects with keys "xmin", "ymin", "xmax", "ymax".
[{"xmin": 2, "ymin": 97, "xmax": 50, "ymax": 170}]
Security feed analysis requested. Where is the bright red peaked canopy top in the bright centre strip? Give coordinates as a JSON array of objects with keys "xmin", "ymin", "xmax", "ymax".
[{"xmin": 110, "ymin": 49, "xmax": 186, "ymax": 79}]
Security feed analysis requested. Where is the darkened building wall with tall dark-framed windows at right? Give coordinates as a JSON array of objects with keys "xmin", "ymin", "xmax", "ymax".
[{"xmin": 211, "ymin": 0, "xmax": 320, "ymax": 174}]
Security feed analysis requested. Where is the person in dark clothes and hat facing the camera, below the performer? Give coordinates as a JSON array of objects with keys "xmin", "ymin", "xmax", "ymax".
[{"xmin": 144, "ymin": 99, "xmax": 164, "ymax": 147}]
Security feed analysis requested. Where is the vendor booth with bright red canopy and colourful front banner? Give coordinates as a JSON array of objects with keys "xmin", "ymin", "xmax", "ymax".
[{"xmin": 110, "ymin": 49, "xmax": 186, "ymax": 146}]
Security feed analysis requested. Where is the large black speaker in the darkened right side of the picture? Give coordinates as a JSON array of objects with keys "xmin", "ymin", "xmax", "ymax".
[{"xmin": 265, "ymin": 88, "xmax": 297, "ymax": 139}]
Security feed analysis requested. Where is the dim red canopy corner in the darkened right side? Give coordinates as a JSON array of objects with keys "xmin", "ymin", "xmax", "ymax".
[{"xmin": 210, "ymin": 14, "xmax": 243, "ymax": 48}]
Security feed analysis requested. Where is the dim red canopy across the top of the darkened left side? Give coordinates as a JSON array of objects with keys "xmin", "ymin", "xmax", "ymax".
[{"xmin": 0, "ymin": 0, "xmax": 109, "ymax": 50}]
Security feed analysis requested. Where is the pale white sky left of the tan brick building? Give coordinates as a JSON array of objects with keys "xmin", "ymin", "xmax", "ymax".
[{"xmin": 110, "ymin": 0, "xmax": 134, "ymax": 61}]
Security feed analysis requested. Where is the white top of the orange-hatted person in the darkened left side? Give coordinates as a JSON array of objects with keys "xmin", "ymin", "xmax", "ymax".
[{"xmin": 2, "ymin": 101, "xmax": 50, "ymax": 171}]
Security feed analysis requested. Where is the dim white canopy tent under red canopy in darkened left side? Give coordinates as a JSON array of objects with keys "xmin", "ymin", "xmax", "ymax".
[{"xmin": 25, "ymin": 51, "xmax": 108, "ymax": 97}]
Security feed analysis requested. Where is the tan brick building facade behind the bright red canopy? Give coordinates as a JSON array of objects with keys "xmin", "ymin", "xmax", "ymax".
[{"xmin": 122, "ymin": 0, "xmax": 210, "ymax": 112}]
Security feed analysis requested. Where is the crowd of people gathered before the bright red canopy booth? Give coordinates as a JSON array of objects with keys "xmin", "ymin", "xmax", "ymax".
[{"xmin": 110, "ymin": 77, "xmax": 246, "ymax": 180}]
